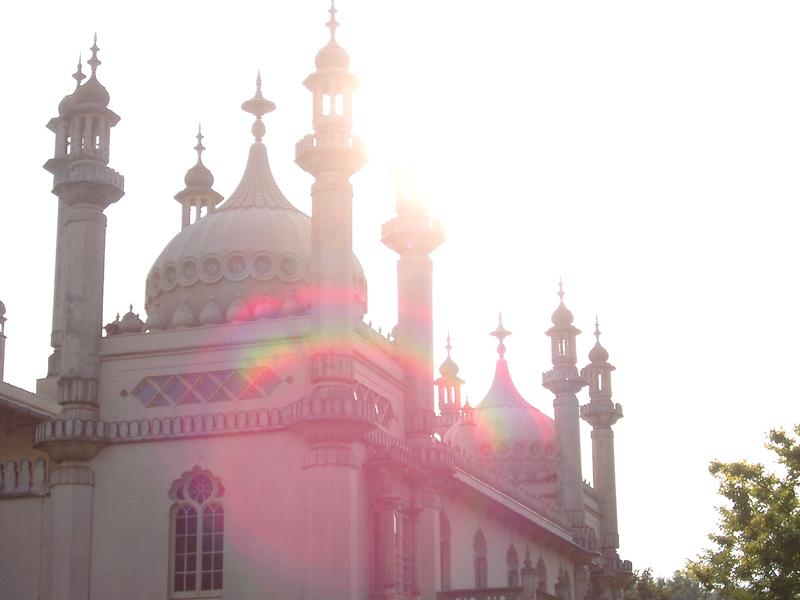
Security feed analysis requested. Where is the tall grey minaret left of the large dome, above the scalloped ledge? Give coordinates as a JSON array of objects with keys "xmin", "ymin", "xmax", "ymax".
[{"xmin": 45, "ymin": 36, "xmax": 125, "ymax": 419}]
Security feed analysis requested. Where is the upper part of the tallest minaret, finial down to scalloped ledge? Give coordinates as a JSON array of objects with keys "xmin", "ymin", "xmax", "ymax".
[{"xmin": 295, "ymin": 2, "xmax": 366, "ymax": 398}]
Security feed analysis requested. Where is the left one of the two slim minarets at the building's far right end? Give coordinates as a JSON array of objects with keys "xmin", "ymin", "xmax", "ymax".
[{"xmin": 542, "ymin": 281, "xmax": 586, "ymax": 541}]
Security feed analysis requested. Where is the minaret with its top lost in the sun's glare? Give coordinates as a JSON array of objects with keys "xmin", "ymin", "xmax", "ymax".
[{"xmin": 381, "ymin": 176, "xmax": 445, "ymax": 444}]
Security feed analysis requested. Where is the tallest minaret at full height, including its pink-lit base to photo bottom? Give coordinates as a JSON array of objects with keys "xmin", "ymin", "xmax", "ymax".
[{"xmin": 294, "ymin": 3, "xmax": 373, "ymax": 600}]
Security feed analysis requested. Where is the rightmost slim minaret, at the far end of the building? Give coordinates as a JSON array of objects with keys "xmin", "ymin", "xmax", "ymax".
[{"xmin": 581, "ymin": 320, "xmax": 622, "ymax": 559}]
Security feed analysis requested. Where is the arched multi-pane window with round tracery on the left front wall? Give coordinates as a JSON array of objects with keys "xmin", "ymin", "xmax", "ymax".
[{"xmin": 169, "ymin": 466, "xmax": 225, "ymax": 598}]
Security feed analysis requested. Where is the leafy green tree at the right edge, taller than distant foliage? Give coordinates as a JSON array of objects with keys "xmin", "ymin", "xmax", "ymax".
[{"xmin": 687, "ymin": 425, "xmax": 800, "ymax": 600}]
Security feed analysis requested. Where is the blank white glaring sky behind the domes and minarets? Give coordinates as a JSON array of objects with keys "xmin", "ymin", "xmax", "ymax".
[{"xmin": 0, "ymin": 0, "xmax": 800, "ymax": 574}]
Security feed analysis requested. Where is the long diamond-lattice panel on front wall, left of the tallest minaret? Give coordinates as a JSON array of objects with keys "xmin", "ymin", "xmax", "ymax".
[{"xmin": 131, "ymin": 367, "xmax": 282, "ymax": 407}]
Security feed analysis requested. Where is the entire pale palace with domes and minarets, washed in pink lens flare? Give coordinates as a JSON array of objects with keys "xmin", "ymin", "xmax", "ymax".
[{"xmin": 0, "ymin": 7, "xmax": 631, "ymax": 600}]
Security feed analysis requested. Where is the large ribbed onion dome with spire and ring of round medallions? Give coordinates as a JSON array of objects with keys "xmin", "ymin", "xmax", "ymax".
[{"xmin": 145, "ymin": 77, "xmax": 367, "ymax": 329}]
